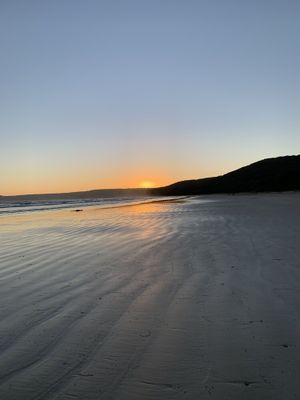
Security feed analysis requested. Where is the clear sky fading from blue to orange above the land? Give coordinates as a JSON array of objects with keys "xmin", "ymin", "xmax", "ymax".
[{"xmin": 0, "ymin": 0, "xmax": 300, "ymax": 195}]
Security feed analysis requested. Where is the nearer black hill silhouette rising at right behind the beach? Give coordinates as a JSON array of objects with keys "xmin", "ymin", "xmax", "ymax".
[{"xmin": 151, "ymin": 155, "xmax": 300, "ymax": 196}]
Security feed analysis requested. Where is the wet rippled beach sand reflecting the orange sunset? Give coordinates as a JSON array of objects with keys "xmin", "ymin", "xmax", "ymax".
[{"xmin": 0, "ymin": 193, "xmax": 300, "ymax": 400}]
